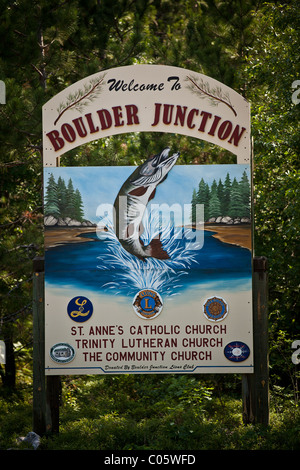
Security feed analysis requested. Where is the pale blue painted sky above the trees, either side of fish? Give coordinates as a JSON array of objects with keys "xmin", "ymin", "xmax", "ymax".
[{"xmin": 44, "ymin": 164, "xmax": 250, "ymax": 223}]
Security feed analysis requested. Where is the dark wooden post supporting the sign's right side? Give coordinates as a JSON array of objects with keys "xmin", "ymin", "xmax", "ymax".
[{"xmin": 242, "ymin": 257, "xmax": 269, "ymax": 426}]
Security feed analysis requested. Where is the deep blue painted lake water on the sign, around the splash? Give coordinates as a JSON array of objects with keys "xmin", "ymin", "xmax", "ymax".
[{"xmin": 45, "ymin": 231, "xmax": 252, "ymax": 295}]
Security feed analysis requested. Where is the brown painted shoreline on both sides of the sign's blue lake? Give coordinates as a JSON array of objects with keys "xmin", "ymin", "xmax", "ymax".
[{"xmin": 44, "ymin": 224, "xmax": 251, "ymax": 250}]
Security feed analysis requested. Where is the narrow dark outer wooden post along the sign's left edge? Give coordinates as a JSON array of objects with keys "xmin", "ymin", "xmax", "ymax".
[{"xmin": 32, "ymin": 257, "xmax": 46, "ymax": 436}]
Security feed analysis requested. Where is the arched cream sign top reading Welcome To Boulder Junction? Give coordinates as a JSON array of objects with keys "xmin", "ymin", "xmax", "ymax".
[{"xmin": 43, "ymin": 65, "xmax": 251, "ymax": 167}]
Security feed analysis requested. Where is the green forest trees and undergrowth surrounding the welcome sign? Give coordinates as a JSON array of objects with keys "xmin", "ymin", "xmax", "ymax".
[{"xmin": 0, "ymin": 0, "xmax": 300, "ymax": 449}]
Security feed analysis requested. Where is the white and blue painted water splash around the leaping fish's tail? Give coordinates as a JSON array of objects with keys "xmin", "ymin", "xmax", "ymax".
[{"xmin": 97, "ymin": 211, "xmax": 202, "ymax": 297}]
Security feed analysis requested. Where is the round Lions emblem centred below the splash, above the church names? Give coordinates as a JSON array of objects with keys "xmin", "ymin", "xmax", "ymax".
[{"xmin": 133, "ymin": 289, "xmax": 163, "ymax": 320}]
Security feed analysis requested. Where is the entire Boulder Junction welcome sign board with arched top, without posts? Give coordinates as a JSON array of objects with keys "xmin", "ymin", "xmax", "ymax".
[{"xmin": 43, "ymin": 65, "xmax": 253, "ymax": 375}]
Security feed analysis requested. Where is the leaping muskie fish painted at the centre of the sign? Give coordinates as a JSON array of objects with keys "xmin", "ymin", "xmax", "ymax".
[{"xmin": 114, "ymin": 148, "xmax": 179, "ymax": 261}]
